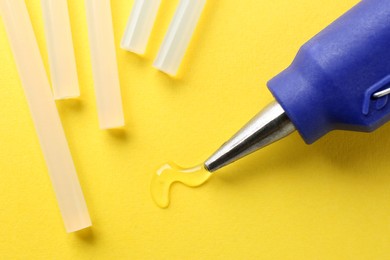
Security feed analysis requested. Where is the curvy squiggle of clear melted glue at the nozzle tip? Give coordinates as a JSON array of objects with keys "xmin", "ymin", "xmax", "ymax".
[{"xmin": 150, "ymin": 163, "xmax": 211, "ymax": 208}]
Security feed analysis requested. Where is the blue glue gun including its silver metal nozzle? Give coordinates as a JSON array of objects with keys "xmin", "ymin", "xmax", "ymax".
[{"xmin": 205, "ymin": 0, "xmax": 390, "ymax": 172}]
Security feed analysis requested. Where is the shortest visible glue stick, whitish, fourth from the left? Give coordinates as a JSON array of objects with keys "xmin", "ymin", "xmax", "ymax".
[{"xmin": 121, "ymin": 0, "xmax": 161, "ymax": 54}]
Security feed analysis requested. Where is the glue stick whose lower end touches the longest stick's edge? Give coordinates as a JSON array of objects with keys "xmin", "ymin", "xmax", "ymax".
[{"xmin": 41, "ymin": 0, "xmax": 80, "ymax": 99}]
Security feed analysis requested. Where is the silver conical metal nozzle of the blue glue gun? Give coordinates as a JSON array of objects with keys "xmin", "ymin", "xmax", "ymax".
[{"xmin": 204, "ymin": 101, "xmax": 295, "ymax": 172}]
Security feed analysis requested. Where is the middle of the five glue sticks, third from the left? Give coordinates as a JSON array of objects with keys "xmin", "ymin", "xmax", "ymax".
[{"xmin": 85, "ymin": 0, "xmax": 124, "ymax": 129}]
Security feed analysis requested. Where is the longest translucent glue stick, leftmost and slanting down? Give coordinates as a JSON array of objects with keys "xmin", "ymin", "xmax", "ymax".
[{"xmin": 0, "ymin": 0, "xmax": 91, "ymax": 232}]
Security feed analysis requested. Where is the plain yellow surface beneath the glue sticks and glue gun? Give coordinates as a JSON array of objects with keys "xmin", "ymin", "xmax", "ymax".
[{"xmin": 0, "ymin": 0, "xmax": 390, "ymax": 259}]
